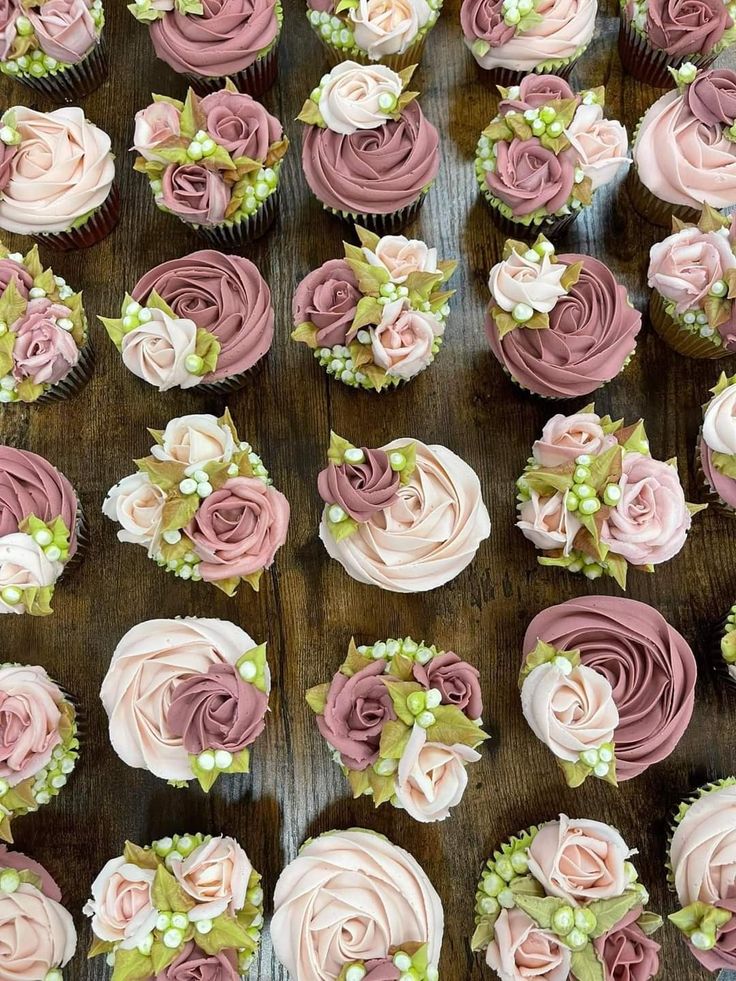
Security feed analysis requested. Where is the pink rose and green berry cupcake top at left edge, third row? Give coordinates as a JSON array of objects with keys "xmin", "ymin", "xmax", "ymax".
[{"xmin": 0, "ymin": 242, "xmax": 87, "ymax": 403}]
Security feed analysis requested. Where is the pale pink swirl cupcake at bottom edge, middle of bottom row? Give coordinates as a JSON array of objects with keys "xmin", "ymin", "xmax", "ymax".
[{"xmin": 271, "ymin": 828, "xmax": 445, "ymax": 981}]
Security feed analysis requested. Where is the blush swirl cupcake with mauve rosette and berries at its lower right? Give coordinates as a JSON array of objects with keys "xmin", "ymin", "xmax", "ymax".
[{"xmin": 100, "ymin": 617, "xmax": 271, "ymax": 793}]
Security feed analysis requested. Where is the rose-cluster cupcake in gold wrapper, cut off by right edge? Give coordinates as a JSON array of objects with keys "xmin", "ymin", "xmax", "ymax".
[{"xmin": 647, "ymin": 204, "xmax": 736, "ymax": 358}]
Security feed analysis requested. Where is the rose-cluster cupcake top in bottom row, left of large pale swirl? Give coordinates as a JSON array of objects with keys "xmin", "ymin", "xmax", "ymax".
[{"xmin": 84, "ymin": 834, "xmax": 263, "ymax": 981}]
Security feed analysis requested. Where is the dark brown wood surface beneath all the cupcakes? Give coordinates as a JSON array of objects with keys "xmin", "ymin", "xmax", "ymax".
[{"xmin": 0, "ymin": 0, "xmax": 736, "ymax": 981}]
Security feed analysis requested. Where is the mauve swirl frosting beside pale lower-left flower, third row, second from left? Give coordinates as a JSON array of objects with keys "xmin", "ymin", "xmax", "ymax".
[{"xmin": 132, "ymin": 249, "xmax": 274, "ymax": 383}]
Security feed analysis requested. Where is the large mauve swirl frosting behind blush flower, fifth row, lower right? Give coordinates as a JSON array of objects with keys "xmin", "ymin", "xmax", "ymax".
[{"xmin": 524, "ymin": 596, "xmax": 697, "ymax": 781}]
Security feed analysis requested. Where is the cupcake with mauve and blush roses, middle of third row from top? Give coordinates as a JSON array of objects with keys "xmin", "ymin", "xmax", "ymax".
[{"xmin": 291, "ymin": 225, "xmax": 457, "ymax": 392}]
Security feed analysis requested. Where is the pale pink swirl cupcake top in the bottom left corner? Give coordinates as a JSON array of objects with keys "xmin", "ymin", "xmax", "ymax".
[{"xmin": 0, "ymin": 845, "xmax": 77, "ymax": 981}]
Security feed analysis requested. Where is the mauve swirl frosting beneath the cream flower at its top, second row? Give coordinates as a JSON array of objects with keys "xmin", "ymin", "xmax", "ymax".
[{"xmin": 302, "ymin": 100, "xmax": 440, "ymax": 214}]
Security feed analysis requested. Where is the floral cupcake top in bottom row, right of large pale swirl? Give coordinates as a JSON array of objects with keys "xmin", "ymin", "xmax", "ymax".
[{"xmin": 471, "ymin": 814, "xmax": 662, "ymax": 981}]
